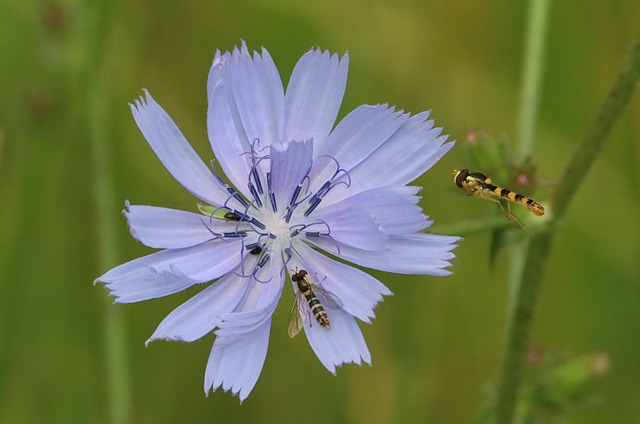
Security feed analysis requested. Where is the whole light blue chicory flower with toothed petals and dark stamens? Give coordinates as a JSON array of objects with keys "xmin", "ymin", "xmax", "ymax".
[{"xmin": 96, "ymin": 43, "xmax": 459, "ymax": 401}]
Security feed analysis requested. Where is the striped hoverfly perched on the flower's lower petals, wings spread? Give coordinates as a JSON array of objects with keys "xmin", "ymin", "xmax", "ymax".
[{"xmin": 289, "ymin": 269, "xmax": 342, "ymax": 338}]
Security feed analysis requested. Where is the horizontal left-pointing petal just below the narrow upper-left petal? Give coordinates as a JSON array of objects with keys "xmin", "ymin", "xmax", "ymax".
[{"xmin": 123, "ymin": 202, "xmax": 220, "ymax": 249}]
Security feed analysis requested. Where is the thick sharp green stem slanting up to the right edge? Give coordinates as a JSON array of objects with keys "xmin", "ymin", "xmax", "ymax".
[{"xmin": 496, "ymin": 35, "xmax": 640, "ymax": 424}]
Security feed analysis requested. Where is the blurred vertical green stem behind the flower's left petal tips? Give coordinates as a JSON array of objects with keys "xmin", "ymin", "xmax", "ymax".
[{"xmin": 74, "ymin": 1, "xmax": 131, "ymax": 424}]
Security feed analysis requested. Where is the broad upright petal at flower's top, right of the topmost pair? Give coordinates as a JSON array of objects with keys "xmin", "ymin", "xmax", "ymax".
[{"xmin": 284, "ymin": 49, "xmax": 349, "ymax": 151}]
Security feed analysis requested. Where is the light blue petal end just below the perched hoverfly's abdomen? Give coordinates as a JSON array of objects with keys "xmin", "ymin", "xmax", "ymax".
[{"xmin": 304, "ymin": 310, "xmax": 371, "ymax": 374}]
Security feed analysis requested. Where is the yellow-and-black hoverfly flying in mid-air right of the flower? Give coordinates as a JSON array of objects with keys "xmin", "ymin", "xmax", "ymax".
[{"xmin": 453, "ymin": 169, "xmax": 544, "ymax": 228}]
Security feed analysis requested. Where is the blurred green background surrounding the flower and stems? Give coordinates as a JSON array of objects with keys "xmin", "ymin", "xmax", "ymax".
[{"xmin": 0, "ymin": 0, "xmax": 640, "ymax": 423}]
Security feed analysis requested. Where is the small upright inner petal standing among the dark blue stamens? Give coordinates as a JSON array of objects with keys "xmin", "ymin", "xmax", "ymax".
[{"xmin": 270, "ymin": 141, "xmax": 313, "ymax": 211}]
